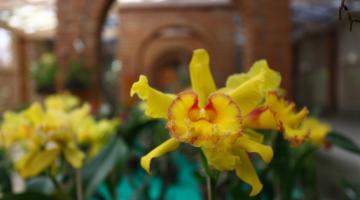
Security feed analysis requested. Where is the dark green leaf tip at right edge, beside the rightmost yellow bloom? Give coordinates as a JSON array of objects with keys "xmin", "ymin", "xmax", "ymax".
[{"xmin": 326, "ymin": 132, "xmax": 360, "ymax": 155}]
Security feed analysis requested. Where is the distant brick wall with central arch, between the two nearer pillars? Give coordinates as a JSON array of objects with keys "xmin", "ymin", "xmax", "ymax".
[{"xmin": 119, "ymin": 6, "xmax": 235, "ymax": 100}]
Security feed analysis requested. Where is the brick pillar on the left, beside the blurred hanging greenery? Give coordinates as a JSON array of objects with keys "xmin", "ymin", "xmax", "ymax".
[{"xmin": 56, "ymin": 0, "xmax": 115, "ymax": 107}]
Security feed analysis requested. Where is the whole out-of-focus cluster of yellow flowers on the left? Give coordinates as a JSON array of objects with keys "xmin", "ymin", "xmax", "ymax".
[{"xmin": 0, "ymin": 94, "xmax": 119, "ymax": 178}]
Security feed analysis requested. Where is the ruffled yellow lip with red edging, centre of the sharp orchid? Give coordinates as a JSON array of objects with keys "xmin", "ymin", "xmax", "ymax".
[{"xmin": 167, "ymin": 91, "xmax": 242, "ymax": 147}]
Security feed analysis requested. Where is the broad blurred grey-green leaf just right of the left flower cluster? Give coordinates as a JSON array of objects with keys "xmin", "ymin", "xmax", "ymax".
[{"xmin": 81, "ymin": 138, "xmax": 128, "ymax": 199}]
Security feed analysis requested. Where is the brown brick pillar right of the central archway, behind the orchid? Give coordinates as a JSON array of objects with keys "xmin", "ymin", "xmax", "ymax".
[{"xmin": 233, "ymin": 0, "xmax": 294, "ymax": 98}]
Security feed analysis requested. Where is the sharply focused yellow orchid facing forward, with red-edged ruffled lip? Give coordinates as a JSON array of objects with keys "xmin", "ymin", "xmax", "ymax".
[{"xmin": 130, "ymin": 49, "xmax": 281, "ymax": 196}]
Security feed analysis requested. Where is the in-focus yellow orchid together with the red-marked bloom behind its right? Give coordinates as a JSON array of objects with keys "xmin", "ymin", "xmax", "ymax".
[{"xmin": 131, "ymin": 49, "xmax": 329, "ymax": 196}]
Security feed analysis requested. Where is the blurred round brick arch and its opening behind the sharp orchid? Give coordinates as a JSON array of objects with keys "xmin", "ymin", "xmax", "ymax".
[{"xmin": 137, "ymin": 24, "xmax": 212, "ymax": 92}]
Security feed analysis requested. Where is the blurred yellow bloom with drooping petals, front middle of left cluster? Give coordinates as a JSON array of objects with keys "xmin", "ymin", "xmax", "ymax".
[{"xmin": 11, "ymin": 103, "xmax": 85, "ymax": 178}]
